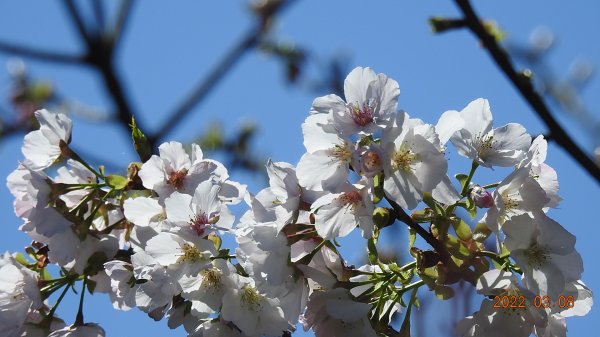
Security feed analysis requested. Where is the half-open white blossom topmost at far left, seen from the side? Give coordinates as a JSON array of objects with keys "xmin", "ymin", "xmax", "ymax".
[{"xmin": 21, "ymin": 109, "xmax": 72, "ymax": 171}]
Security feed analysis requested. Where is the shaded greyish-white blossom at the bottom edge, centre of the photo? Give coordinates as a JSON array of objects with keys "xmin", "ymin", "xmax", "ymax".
[{"xmin": 301, "ymin": 288, "xmax": 377, "ymax": 337}]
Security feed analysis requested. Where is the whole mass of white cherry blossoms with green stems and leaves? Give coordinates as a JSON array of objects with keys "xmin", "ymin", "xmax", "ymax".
[{"xmin": 0, "ymin": 68, "xmax": 592, "ymax": 337}]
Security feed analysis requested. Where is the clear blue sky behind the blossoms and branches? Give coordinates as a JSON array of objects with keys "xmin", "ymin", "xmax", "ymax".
[{"xmin": 0, "ymin": 0, "xmax": 600, "ymax": 337}]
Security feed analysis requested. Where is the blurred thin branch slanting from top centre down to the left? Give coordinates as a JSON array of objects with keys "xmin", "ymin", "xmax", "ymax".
[{"xmin": 149, "ymin": 0, "xmax": 293, "ymax": 142}]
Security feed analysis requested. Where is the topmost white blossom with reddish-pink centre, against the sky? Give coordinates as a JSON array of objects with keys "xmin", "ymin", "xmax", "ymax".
[{"xmin": 312, "ymin": 67, "xmax": 400, "ymax": 137}]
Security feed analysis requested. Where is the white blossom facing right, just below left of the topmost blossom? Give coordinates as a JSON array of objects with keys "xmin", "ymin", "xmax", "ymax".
[{"xmin": 296, "ymin": 114, "xmax": 354, "ymax": 191}]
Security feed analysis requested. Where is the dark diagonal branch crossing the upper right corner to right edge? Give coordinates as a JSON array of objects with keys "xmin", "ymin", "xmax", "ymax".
[{"xmin": 454, "ymin": 0, "xmax": 600, "ymax": 184}]
